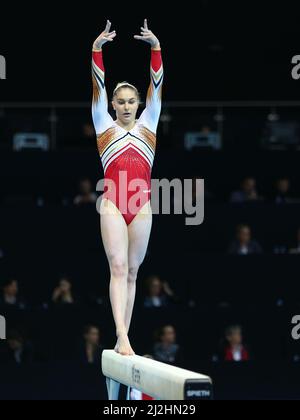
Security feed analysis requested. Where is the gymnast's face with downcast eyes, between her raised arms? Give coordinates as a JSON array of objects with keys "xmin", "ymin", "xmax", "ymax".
[{"xmin": 112, "ymin": 87, "xmax": 139, "ymax": 125}]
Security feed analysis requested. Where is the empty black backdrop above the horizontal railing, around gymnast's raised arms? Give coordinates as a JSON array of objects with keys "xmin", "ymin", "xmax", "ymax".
[{"xmin": 0, "ymin": 0, "xmax": 300, "ymax": 101}]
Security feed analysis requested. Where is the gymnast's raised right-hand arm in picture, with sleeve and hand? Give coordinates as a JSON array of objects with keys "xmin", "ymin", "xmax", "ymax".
[{"xmin": 134, "ymin": 19, "xmax": 164, "ymax": 133}]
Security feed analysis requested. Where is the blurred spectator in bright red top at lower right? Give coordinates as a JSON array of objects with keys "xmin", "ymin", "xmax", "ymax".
[{"xmin": 220, "ymin": 325, "xmax": 250, "ymax": 362}]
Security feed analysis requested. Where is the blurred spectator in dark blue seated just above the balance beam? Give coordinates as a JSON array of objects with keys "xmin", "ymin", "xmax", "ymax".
[{"xmin": 153, "ymin": 325, "xmax": 180, "ymax": 365}]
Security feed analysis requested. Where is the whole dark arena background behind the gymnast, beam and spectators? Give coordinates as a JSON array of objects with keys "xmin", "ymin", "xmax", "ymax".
[{"xmin": 0, "ymin": 1, "xmax": 300, "ymax": 399}]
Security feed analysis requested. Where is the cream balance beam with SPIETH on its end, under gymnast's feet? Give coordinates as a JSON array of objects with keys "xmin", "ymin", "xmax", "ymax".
[{"xmin": 102, "ymin": 350, "xmax": 212, "ymax": 400}]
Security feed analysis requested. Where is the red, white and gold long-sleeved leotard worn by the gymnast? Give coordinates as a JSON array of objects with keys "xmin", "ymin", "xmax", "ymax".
[{"xmin": 92, "ymin": 50, "xmax": 163, "ymax": 225}]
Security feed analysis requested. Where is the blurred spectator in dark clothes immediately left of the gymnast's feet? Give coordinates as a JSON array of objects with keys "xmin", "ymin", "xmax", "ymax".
[{"xmin": 78, "ymin": 325, "xmax": 104, "ymax": 365}]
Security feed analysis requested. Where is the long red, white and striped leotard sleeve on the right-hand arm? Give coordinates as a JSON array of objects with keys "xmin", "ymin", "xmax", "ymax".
[{"xmin": 139, "ymin": 50, "xmax": 164, "ymax": 133}]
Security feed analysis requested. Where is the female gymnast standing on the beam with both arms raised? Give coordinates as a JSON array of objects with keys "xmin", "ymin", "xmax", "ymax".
[{"xmin": 92, "ymin": 19, "xmax": 163, "ymax": 355}]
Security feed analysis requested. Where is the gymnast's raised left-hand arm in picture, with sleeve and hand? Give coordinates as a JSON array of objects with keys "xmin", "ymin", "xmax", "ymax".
[{"xmin": 92, "ymin": 20, "xmax": 116, "ymax": 135}]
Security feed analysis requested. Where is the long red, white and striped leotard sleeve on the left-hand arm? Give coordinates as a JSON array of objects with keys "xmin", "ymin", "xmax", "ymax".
[{"xmin": 92, "ymin": 51, "xmax": 113, "ymax": 135}]
